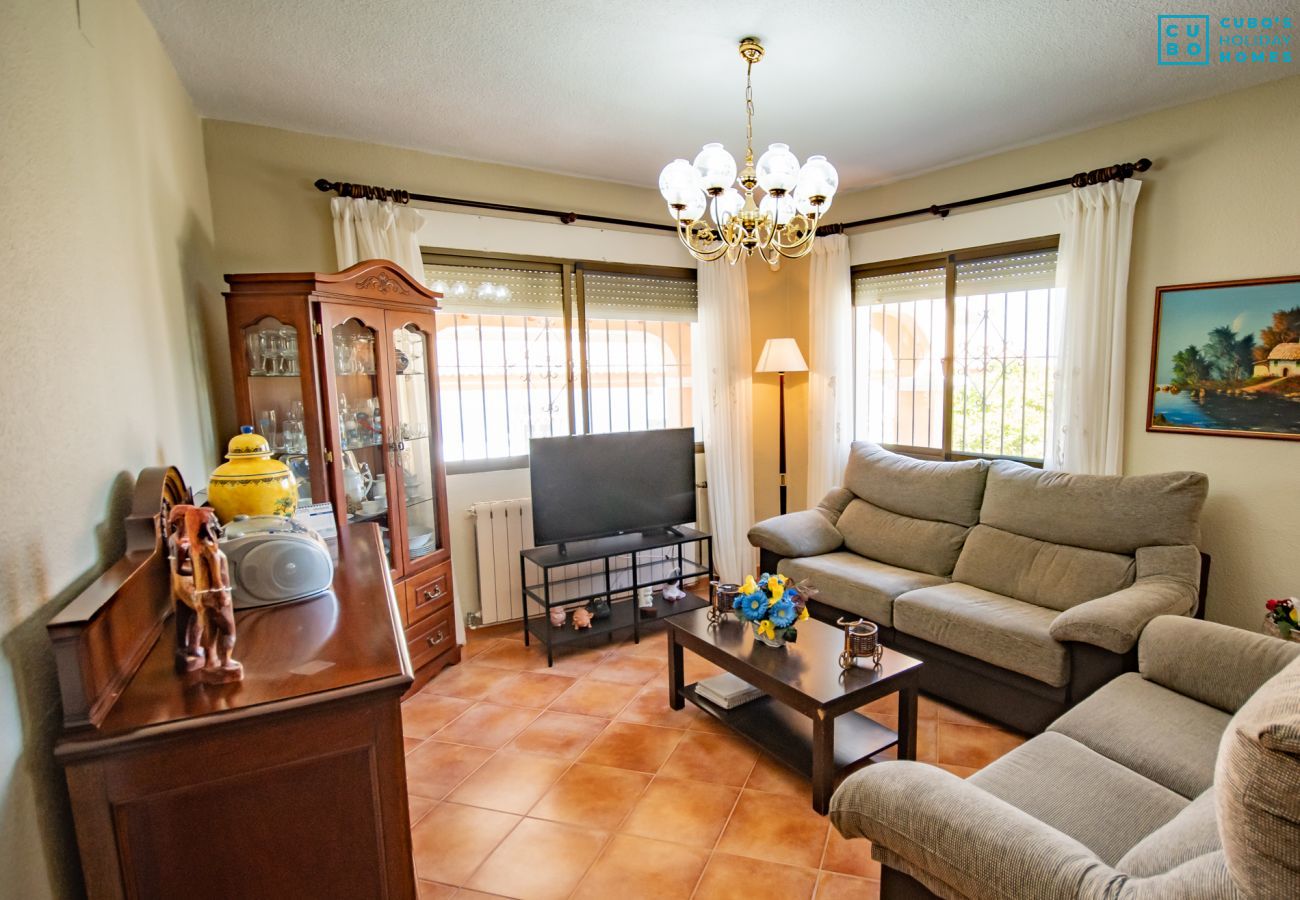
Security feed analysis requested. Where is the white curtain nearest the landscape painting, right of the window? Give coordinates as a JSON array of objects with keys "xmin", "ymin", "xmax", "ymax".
[{"xmin": 1044, "ymin": 178, "xmax": 1141, "ymax": 475}]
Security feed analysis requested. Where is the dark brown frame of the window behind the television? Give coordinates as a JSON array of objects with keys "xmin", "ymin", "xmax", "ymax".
[{"xmin": 420, "ymin": 247, "xmax": 705, "ymax": 475}]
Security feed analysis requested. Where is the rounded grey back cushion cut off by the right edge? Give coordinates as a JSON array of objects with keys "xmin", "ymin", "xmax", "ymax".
[{"xmin": 1214, "ymin": 659, "xmax": 1300, "ymax": 897}]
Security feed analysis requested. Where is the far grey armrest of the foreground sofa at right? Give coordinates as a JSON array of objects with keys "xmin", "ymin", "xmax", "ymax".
[{"xmin": 1138, "ymin": 616, "xmax": 1300, "ymax": 713}]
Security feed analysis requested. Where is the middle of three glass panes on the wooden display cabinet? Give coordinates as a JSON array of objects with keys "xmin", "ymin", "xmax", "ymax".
[{"xmin": 322, "ymin": 312, "xmax": 398, "ymax": 570}]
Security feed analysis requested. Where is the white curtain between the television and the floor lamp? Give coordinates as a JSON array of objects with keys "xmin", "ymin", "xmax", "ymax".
[{"xmin": 696, "ymin": 260, "xmax": 757, "ymax": 581}]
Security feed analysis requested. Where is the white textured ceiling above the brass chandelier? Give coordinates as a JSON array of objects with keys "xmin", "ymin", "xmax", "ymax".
[{"xmin": 142, "ymin": 0, "xmax": 1296, "ymax": 190}]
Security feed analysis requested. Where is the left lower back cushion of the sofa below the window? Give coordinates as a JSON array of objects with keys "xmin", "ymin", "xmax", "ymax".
[{"xmin": 837, "ymin": 499, "xmax": 970, "ymax": 577}]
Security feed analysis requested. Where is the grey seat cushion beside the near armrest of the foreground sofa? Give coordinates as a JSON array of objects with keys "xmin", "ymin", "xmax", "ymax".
[{"xmin": 967, "ymin": 732, "xmax": 1187, "ymax": 865}]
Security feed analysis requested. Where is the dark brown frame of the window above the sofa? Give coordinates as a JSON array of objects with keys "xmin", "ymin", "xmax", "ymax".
[{"xmin": 849, "ymin": 234, "xmax": 1061, "ymax": 468}]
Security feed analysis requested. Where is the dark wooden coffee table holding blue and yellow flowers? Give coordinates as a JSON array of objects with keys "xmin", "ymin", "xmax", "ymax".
[{"xmin": 667, "ymin": 610, "xmax": 922, "ymax": 815}]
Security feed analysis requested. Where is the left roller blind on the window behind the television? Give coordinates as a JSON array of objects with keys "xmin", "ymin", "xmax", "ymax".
[{"xmin": 424, "ymin": 264, "xmax": 564, "ymax": 316}]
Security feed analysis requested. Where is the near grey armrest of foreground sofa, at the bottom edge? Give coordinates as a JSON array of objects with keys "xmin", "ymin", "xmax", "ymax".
[{"xmin": 831, "ymin": 761, "xmax": 1118, "ymax": 900}]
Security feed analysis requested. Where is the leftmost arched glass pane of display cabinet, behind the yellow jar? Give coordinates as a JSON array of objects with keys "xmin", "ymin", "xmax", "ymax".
[{"xmin": 239, "ymin": 316, "xmax": 312, "ymax": 505}]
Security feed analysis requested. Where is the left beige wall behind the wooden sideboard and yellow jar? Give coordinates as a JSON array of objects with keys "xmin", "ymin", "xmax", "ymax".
[{"xmin": 0, "ymin": 0, "xmax": 217, "ymax": 900}]
